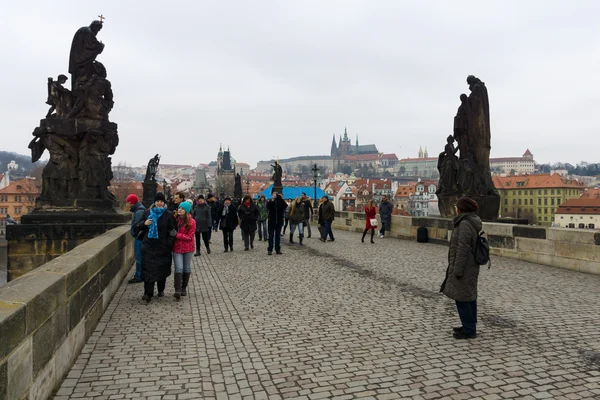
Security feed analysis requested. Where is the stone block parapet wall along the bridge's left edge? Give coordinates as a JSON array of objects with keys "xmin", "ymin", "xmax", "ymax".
[{"xmin": 0, "ymin": 226, "xmax": 133, "ymax": 400}]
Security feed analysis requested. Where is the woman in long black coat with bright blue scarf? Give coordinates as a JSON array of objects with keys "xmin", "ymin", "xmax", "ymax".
[{"xmin": 137, "ymin": 192, "xmax": 177, "ymax": 302}]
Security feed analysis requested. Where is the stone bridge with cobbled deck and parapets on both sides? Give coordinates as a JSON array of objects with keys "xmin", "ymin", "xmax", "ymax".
[{"xmin": 0, "ymin": 213, "xmax": 600, "ymax": 400}]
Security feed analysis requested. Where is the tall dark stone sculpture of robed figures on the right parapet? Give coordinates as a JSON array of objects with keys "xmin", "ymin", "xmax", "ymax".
[{"xmin": 437, "ymin": 75, "xmax": 500, "ymax": 220}]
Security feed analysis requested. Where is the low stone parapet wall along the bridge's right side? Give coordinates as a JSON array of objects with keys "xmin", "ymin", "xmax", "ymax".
[{"xmin": 333, "ymin": 212, "xmax": 600, "ymax": 275}]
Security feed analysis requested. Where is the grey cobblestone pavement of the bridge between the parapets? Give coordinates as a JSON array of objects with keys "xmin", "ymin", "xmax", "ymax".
[{"xmin": 55, "ymin": 227, "xmax": 600, "ymax": 400}]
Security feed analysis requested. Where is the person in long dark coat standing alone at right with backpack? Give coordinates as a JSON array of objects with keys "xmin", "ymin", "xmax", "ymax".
[{"xmin": 440, "ymin": 197, "xmax": 483, "ymax": 339}]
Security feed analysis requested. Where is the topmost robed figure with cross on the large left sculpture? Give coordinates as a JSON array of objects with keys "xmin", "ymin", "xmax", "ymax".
[{"xmin": 69, "ymin": 21, "xmax": 104, "ymax": 90}]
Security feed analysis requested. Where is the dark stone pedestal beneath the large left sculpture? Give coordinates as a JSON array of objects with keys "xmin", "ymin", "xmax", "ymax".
[{"xmin": 6, "ymin": 207, "xmax": 131, "ymax": 281}]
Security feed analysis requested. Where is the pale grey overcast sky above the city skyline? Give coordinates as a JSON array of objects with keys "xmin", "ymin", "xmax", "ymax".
[{"xmin": 0, "ymin": 0, "xmax": 600, "ymax": 167}]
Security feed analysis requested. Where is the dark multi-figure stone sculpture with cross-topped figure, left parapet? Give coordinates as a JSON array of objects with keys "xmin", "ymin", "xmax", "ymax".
[{"xmin": 29, "ymin": 21, "xmax": 119, "ymax": 209}]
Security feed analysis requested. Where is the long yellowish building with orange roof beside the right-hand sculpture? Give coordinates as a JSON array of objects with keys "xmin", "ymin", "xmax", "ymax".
[{"xmin": 492, "ymin": 174, "xmax": 584, "ymax": 226}]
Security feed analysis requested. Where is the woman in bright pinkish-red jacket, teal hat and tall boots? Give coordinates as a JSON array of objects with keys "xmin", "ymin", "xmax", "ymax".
[{"xmin": 173, "ymin": 201, "xmax": 196, "ymax": 300}]
